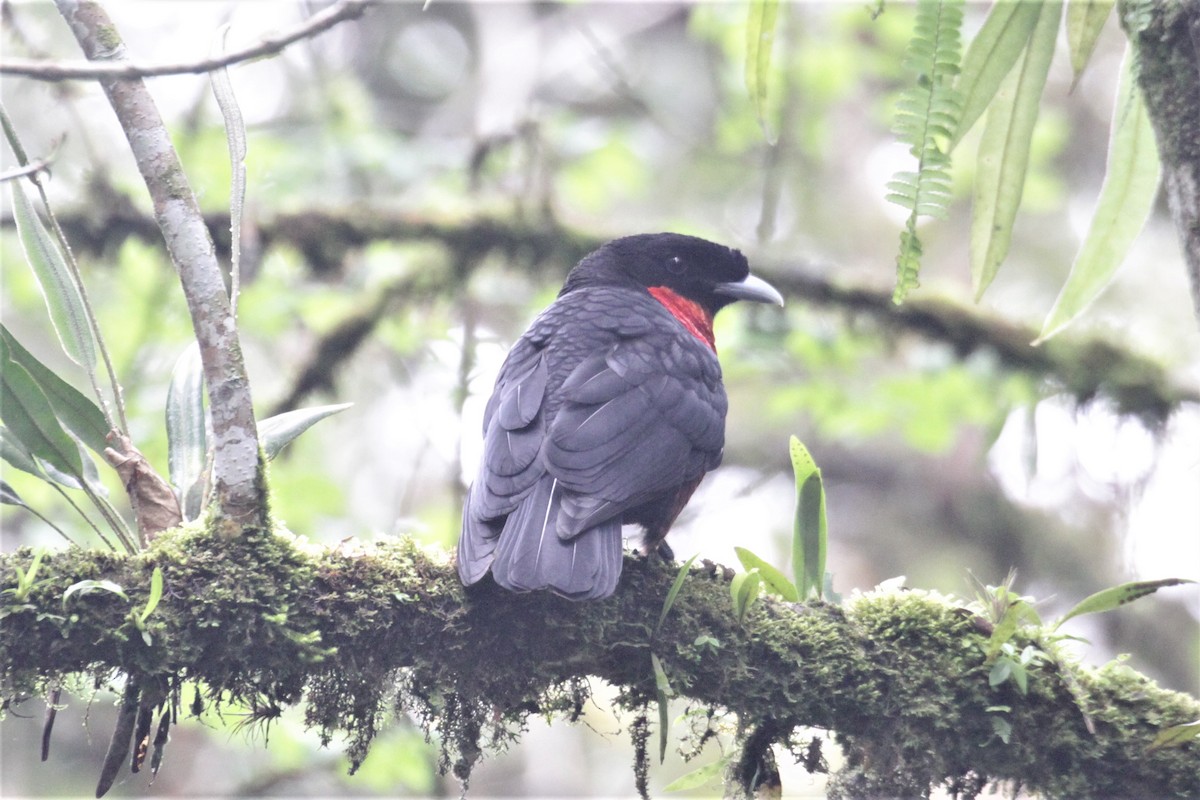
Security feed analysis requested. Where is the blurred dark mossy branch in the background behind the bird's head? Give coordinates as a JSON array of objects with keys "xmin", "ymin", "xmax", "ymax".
[{"xmin": 4, "ymin": 203, "xmax": 1200, "ymax": 425}]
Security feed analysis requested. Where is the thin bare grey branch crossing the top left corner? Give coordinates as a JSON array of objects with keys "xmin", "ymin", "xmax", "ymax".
[{"xmin": 0, "ymin": 0, "xmax": 374, "ymax": 80}]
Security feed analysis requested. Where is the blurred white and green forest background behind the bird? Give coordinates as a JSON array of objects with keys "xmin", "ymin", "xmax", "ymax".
[{"xmin": 0, "ymin": 0, "xmax": 1200, "ymax": 796}]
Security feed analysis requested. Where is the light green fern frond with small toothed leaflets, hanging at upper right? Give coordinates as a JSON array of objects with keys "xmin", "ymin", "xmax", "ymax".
[{"xmin": 887, "ymin": 0, "xmax": 962, "ymax": 303}]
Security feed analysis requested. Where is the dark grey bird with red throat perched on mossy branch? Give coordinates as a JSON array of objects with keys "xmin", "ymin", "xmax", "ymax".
[{"xmin": 457, "ymin": 233, "xmax": 784, "ymax": 601}]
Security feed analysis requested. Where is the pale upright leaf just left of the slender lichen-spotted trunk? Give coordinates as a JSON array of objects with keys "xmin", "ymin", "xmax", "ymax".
[{"xmin": 167, "ymin": 342, "xmax": 208, "ymax": 521}]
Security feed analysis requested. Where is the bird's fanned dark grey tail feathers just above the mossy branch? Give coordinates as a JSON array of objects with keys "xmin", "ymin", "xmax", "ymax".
[{"xmin": 487, "ymin": 479, "xmax": 623, "ymax": 600}]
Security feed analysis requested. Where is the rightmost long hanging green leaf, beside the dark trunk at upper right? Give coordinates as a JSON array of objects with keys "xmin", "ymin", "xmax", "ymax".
[{"xmin": 1037, "ymin": 48, "xmax": 1162, "ymax": 342}]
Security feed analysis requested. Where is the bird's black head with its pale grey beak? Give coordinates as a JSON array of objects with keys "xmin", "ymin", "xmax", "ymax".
[{"xmin": 559, "ymin": 233, "xmax": 784, "ymax": 320}]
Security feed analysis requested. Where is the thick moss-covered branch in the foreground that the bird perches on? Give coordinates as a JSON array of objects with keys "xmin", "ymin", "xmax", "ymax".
[{"xmin": 0, "ymin": 531, "xmax": 1200, "ymax": 798}]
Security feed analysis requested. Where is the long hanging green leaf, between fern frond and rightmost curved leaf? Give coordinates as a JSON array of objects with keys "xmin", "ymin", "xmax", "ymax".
[{"xmin": 971, "ymin": 0, "xmax": 1062, "ymax": 300}]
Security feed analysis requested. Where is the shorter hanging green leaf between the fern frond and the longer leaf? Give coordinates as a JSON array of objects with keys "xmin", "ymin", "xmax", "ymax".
[{"xmin": 948, "ymin": 0, "xmax": 1039, "ymax": 150}]
